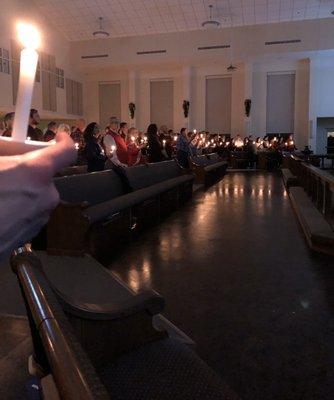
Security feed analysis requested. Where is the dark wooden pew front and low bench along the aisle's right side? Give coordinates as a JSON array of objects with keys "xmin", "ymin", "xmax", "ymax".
[{"xmin": 282, "ymin": 155, "xmax": 334, "ymax": 255}]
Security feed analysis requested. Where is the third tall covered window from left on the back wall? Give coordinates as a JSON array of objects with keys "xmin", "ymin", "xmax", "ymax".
[{"xmin": 205, "ymin": 76, "xmax": 232, "ymax": 133}]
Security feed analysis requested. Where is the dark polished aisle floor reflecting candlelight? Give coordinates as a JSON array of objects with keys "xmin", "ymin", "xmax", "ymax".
[{"xmin": 110, "ymin": 172, "xmax": 334, "ymax": 400}]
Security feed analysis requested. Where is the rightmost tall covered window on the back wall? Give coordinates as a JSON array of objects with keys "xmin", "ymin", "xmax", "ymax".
[{"xmin": 267, "ymin": 72, "xmax": 295, "ymax": 134}]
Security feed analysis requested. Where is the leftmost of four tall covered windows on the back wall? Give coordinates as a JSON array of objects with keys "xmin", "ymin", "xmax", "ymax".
[{"xmin": 99, "ymin": 82, "xmax": 121, "ymax": 128}]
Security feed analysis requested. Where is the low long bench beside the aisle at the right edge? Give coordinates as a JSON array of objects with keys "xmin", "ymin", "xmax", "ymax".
[{"xmin": 289, "ymin": 187, "xmax": 334, "ymax": 255}]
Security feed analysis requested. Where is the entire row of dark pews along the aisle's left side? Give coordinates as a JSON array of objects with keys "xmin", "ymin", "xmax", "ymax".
[{"xmin": 11, "ymin": 156, "xmax": 238, "ymax": 400}]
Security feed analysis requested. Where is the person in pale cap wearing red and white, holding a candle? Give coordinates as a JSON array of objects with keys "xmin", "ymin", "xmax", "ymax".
[{"xmin": 103, "ymin": 117, "xmax": 129, "ymax": 167}]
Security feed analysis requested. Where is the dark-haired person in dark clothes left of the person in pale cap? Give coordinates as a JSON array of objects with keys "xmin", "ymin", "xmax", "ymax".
[{"xmin": 84, "ymin": 122, "xmax": 108, "ymax": 172}]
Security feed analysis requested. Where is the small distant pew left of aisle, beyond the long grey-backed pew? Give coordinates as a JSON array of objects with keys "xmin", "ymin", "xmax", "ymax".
[{"xmin": 189, "ymin": 153, "xmax": 227, "ymax": 186}]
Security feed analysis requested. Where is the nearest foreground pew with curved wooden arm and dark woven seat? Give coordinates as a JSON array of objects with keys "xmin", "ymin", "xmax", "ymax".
[{"xmin": 12, "ymin": 252, "xmax": 238, "ymax": 400}]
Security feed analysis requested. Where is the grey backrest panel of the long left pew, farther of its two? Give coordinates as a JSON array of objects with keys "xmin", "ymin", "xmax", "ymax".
[{"xmin": 125, "ymin": 160, "xmax": 181, "ymax": 190}]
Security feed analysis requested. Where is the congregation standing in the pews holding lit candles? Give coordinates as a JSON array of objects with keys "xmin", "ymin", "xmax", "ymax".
[{"xmin": 0, "ymin": 109, "xmax": 296, "ymax": 172}]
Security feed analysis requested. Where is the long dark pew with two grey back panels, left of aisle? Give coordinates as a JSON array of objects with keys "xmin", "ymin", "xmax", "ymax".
[{"xmin": 46, "ymin": 161, "xmax": 194, "ymax": 260}]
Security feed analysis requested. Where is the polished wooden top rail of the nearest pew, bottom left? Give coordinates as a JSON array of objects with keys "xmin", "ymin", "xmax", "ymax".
[{"xmin": 12, "ymin": 248, "xmax": 110, "ymax": 400}]
